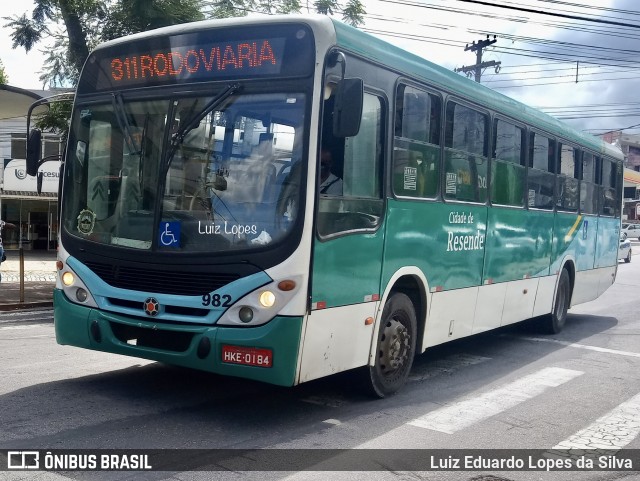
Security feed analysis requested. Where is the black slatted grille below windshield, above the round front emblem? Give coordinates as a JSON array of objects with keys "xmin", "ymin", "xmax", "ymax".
[{"xmin": 86, "ymin": 262, "xmax": 240, "ymax": 296}]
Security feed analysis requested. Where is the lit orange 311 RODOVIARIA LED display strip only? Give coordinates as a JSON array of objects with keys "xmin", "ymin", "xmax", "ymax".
[{"xmin": 110, "ymin": 38, "xmax": 284, "ymax": 82}]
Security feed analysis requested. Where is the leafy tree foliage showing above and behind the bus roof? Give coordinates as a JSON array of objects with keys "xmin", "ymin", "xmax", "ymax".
[{"xmin": 3, "ymin": 0, "xmax": 365, "ymax": 87}]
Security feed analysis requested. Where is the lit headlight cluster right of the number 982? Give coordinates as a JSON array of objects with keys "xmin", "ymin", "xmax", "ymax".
[{"xmin": 216, "ymin": 279, "xmax": 300, "ymax": 327}]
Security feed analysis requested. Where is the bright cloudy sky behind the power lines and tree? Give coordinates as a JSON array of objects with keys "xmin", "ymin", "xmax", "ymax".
[{"xmin": 0, "ymin": 0, "xmax": 640, "ymax": 133}]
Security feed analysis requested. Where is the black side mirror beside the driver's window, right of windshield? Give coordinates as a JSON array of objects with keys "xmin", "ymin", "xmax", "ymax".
[{"xmin": 333, "ymin": 78, "xmax": 364, "ymax": 137}]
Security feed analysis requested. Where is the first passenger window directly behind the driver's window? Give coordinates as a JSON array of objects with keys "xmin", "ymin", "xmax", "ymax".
[{"xmin": 393, "ymin": 85, "xmax": 441, "ymax": 198}]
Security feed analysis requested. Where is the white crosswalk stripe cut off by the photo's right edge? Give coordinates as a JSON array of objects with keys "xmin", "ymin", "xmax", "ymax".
[{"xmin": 553, "ymin": 394, "xmax": 640, "ymax": 449}]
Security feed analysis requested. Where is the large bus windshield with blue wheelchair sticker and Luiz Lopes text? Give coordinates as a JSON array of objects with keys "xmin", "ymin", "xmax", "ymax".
[{"xmin": 63, "ymin": 88, "xmax": 305, "ymax": 252}]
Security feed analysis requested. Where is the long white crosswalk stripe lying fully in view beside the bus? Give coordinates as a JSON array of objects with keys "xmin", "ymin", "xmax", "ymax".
[{"xmin": 407, "ymin": 367, "xmax": 584, "ymax": 434}]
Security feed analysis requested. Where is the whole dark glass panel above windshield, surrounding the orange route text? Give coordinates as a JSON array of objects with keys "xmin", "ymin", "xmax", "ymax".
[{"xmin": 78, "ymin": 24, "xmax": 315, "ymax": 94}]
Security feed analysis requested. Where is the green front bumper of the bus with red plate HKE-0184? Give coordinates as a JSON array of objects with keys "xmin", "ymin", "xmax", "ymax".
[{"xmin": 53, "ymin": 289, "xmax": 302, "ymax": 386}]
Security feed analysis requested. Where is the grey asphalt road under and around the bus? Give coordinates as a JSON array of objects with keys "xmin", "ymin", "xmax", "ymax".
[{"xmin": 0, "ymin": 257, "xmax": 640, "ymax": 481}]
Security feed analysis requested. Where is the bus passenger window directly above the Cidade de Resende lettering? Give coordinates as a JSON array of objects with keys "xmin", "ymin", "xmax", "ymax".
[{"xmin": 444, "ymin": 102, "xmax": 488, "ymax": 202}]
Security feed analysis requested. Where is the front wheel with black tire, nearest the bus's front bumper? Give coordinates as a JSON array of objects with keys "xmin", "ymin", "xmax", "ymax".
[{"xmin": 363, "ymin": 293, "xmax": 418, "ymax": 398}]
